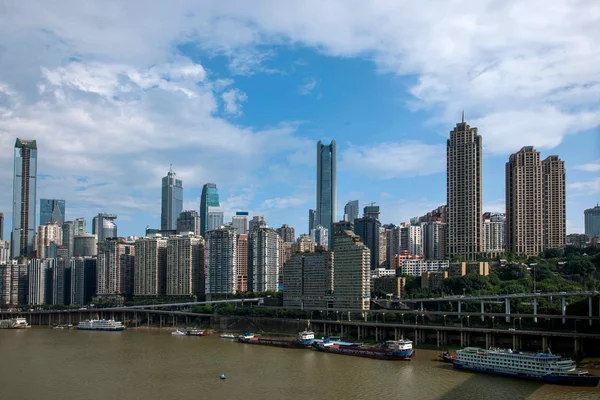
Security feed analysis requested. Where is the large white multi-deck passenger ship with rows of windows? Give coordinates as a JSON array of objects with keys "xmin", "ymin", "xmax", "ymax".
[{"xmin": 454, "ymin": 347, "xmax": 600, "ymax": 387}]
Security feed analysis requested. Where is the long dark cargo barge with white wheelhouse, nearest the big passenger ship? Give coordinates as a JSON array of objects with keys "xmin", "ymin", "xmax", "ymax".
[{"xmin": 316, "ymin": 339, "xmax": 414, "ymax": 360}]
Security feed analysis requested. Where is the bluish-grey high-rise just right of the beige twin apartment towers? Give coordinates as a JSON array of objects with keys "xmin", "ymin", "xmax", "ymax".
[{"xmin": 206, "ymin": 226, "xmax": 238, "ymax": 295}]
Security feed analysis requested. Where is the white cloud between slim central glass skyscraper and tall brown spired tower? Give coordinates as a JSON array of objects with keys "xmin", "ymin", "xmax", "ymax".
[{"xmin": 341, "ymin": 141, "xmax": 446, "ymax": 179}]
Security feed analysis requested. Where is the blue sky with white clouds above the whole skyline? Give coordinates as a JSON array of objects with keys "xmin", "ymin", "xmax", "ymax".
[{"xmin": 0, "ymin": 0, "xmax": 600, "ymax": 236}]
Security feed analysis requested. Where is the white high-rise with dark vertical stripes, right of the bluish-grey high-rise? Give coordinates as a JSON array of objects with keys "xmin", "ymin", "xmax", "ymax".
[{"xmin": 248, "ymin": 228, "xmax": 279, "ymax": 292}]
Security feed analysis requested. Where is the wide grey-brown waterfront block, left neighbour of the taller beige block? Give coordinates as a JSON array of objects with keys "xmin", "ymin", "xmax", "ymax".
[{"xmin": 283, "ymin": 251, "xmax": 334, "ymax": 309}]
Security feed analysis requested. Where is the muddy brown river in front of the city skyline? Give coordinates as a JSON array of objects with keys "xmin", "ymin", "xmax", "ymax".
[{"xmin": 0, "ymin": 327, "xmax": 600, "ymax": 400}]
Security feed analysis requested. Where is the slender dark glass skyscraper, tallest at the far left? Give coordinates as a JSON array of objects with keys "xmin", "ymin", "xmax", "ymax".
[{"xmin": 10, "ymin": 139, "xmax": 37, "ymax": 258}]
